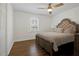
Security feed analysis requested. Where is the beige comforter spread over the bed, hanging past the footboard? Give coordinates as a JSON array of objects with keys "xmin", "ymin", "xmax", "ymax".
[{"xmin": 37, "ymin": 32, "xmax": 74, "ymax": 51}]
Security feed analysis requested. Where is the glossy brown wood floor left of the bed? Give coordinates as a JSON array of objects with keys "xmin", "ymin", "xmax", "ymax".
[{"xmin": 9, "ymin": 40, "xmax": 49, "ymax": 56}]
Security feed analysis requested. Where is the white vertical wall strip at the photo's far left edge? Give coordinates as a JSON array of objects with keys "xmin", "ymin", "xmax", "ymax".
[{"xmin": 0, "ymin": 4, "xmax": 7, "ymax": 56}]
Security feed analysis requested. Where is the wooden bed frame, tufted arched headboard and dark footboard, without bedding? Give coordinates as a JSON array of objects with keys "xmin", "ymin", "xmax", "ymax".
[{"xmin": 36, "ymin": 18, "xmax": 76, "ymax": 56}]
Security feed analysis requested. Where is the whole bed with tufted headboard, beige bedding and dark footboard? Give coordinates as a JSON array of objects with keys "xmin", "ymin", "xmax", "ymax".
[{"xmin": 36, "ymin": 18, "xmax": 76, "ymax": 55}]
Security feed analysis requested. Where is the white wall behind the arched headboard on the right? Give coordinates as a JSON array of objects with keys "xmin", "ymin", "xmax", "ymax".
[{"xmin": 51, "ymin": 7, "xmax": 79, "ymax": 27}]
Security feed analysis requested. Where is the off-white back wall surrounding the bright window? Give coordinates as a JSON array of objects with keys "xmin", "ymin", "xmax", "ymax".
[{"xmin": 14, "ymin": 10, "xmax": 51, "ymax": 41}]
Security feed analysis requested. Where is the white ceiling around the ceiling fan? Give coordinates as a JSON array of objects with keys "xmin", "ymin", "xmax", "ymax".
[{"xmin": 12, "ymin": 3, "xmax": 79, "ymax": 15}]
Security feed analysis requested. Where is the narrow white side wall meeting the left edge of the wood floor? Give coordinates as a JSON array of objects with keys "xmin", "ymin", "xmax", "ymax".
[{"xmin": 7, "ymin": 4, "xmax": 14, "ymax": 54}]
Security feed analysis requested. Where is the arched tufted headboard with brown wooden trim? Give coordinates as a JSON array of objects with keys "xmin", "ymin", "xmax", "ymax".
[{"xmin": 57, "ymin": 18, "xmax": 77, "ymax": 31}]
